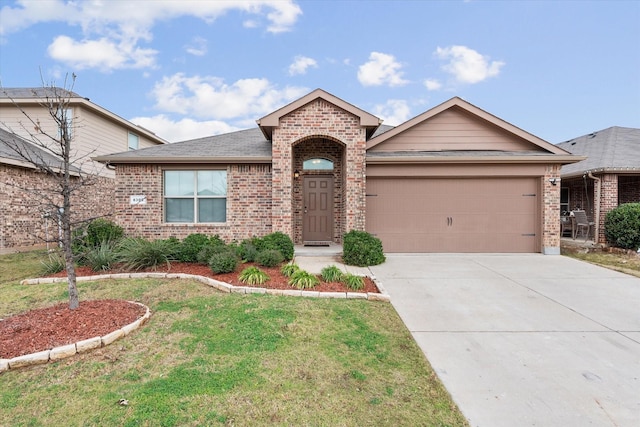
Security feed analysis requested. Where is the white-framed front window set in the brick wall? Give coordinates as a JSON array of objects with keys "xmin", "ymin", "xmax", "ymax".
[{"xmin": 164, "ymin": 170, "xmax": 227, "ymax": 223}]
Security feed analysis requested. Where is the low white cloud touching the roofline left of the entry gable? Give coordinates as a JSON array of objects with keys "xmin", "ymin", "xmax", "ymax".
[{"xmin": 130, "ymin": 114, "xmax": 239, "ymax": 142}]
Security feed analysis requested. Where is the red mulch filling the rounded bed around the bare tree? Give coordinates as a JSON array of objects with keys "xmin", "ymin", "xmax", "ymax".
[{"xmin": 0, "ymin": 300, "xmax": 146, "ymax": 359}]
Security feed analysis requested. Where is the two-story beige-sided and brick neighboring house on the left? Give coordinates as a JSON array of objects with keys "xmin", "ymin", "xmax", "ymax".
[{"xmin": 0, "ymin": 88, "xmax": 166, "ymax": 251}]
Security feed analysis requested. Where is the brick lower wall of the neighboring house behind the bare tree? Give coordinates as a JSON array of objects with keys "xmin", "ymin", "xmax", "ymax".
[{"xmin": 0, "ymin": 164, "xmax": 115, "ymax": 250}]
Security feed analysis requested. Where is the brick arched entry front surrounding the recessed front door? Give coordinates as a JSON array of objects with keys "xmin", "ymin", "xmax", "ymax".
[{"xmin": 272, "ymin": 99, "xmax": 366, "ymax": 242}]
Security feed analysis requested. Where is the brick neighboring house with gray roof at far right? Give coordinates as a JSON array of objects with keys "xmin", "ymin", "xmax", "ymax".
[{"xmin": 557, "ymin": 126, "xmax": 640, "ymax": 243}]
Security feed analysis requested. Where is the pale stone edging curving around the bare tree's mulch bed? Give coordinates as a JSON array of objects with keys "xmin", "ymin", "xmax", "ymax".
[{"xmin": 0, "ymin": 300, "xmax": 151, "ymax": 373}]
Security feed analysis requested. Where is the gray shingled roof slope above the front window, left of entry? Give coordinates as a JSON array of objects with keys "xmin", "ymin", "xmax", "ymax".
[{"xmin": 93, "ymin": 128, "xmax": 271, "ymax": 164}]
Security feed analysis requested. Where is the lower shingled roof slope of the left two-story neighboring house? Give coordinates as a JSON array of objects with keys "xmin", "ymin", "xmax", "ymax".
[{"xmin": 0, "ymin": 128, "xmax": 79, "ymax": 174}]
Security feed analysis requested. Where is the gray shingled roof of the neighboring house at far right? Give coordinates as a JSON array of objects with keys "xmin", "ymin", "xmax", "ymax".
[{"xmin": 557, "ymin": 126, "xmax": 640, "ymax": 177}]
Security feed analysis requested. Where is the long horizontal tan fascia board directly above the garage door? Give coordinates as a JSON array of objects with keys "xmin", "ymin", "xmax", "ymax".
[{"xmin": 366, "ymin": 154, "xmax": 585, "ymax": 165}]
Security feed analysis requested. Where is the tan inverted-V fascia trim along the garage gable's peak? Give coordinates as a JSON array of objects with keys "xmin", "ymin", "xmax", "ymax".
[{"xmin": 367, "ymin": 96, "xmax": 570, "ymax": 155}]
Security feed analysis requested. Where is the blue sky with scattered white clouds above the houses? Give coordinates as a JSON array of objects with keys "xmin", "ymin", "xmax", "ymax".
[{"xmin": 0, "ymin": 0, "xmax": 640, "ymax": 143}]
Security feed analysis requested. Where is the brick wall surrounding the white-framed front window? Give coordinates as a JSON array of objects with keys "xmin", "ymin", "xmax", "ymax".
[{"xmin": 116, "ymin": 164, "xmax": 271, "ymax": 242}]
